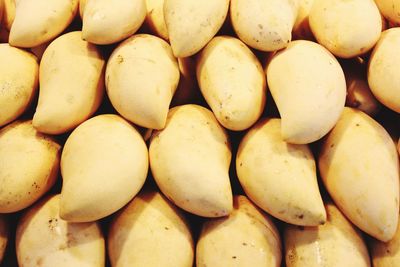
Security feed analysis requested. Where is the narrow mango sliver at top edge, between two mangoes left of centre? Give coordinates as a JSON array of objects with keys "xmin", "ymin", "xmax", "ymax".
[{"xmin": 146, "ymin": 0, "xmax": 169, "ymax": 40}]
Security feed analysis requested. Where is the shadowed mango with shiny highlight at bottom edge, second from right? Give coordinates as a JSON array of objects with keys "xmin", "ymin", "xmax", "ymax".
[{"xmin": 283, "ymin": 204, "xmax": 371, "ymax": 267}]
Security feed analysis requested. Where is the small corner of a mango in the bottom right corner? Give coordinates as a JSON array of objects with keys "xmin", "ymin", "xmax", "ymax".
[{"xmin": 370, "ymin": 219, "xmax": 400, "ymax": 267}]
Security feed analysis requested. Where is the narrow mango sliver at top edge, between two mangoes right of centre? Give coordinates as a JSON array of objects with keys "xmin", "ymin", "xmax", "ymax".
[{"xmin": 293, "ymin": 0, "xmax": 315, "ymax": 40}]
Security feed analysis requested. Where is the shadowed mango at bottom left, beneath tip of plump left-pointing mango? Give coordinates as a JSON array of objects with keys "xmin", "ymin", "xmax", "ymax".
[{"xmin": 16, "ymin": 195, "xmax": 105, "ymax": 267}]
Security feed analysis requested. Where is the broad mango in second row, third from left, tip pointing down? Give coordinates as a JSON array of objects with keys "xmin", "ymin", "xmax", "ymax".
[{"xmin": 106, "ymin": 34, "xmax": 179, "ymax": 129}]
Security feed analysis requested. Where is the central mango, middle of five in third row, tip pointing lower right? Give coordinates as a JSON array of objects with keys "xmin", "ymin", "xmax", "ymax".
[{"xmin": 149, "ymin": 105, "xmax": 232, "ymax": 217}]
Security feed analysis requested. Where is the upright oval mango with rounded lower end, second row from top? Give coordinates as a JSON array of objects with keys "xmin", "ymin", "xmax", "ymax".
[{"xmin": 196, "ymin": 36, "xmax": 266, "ymax": 131}]
